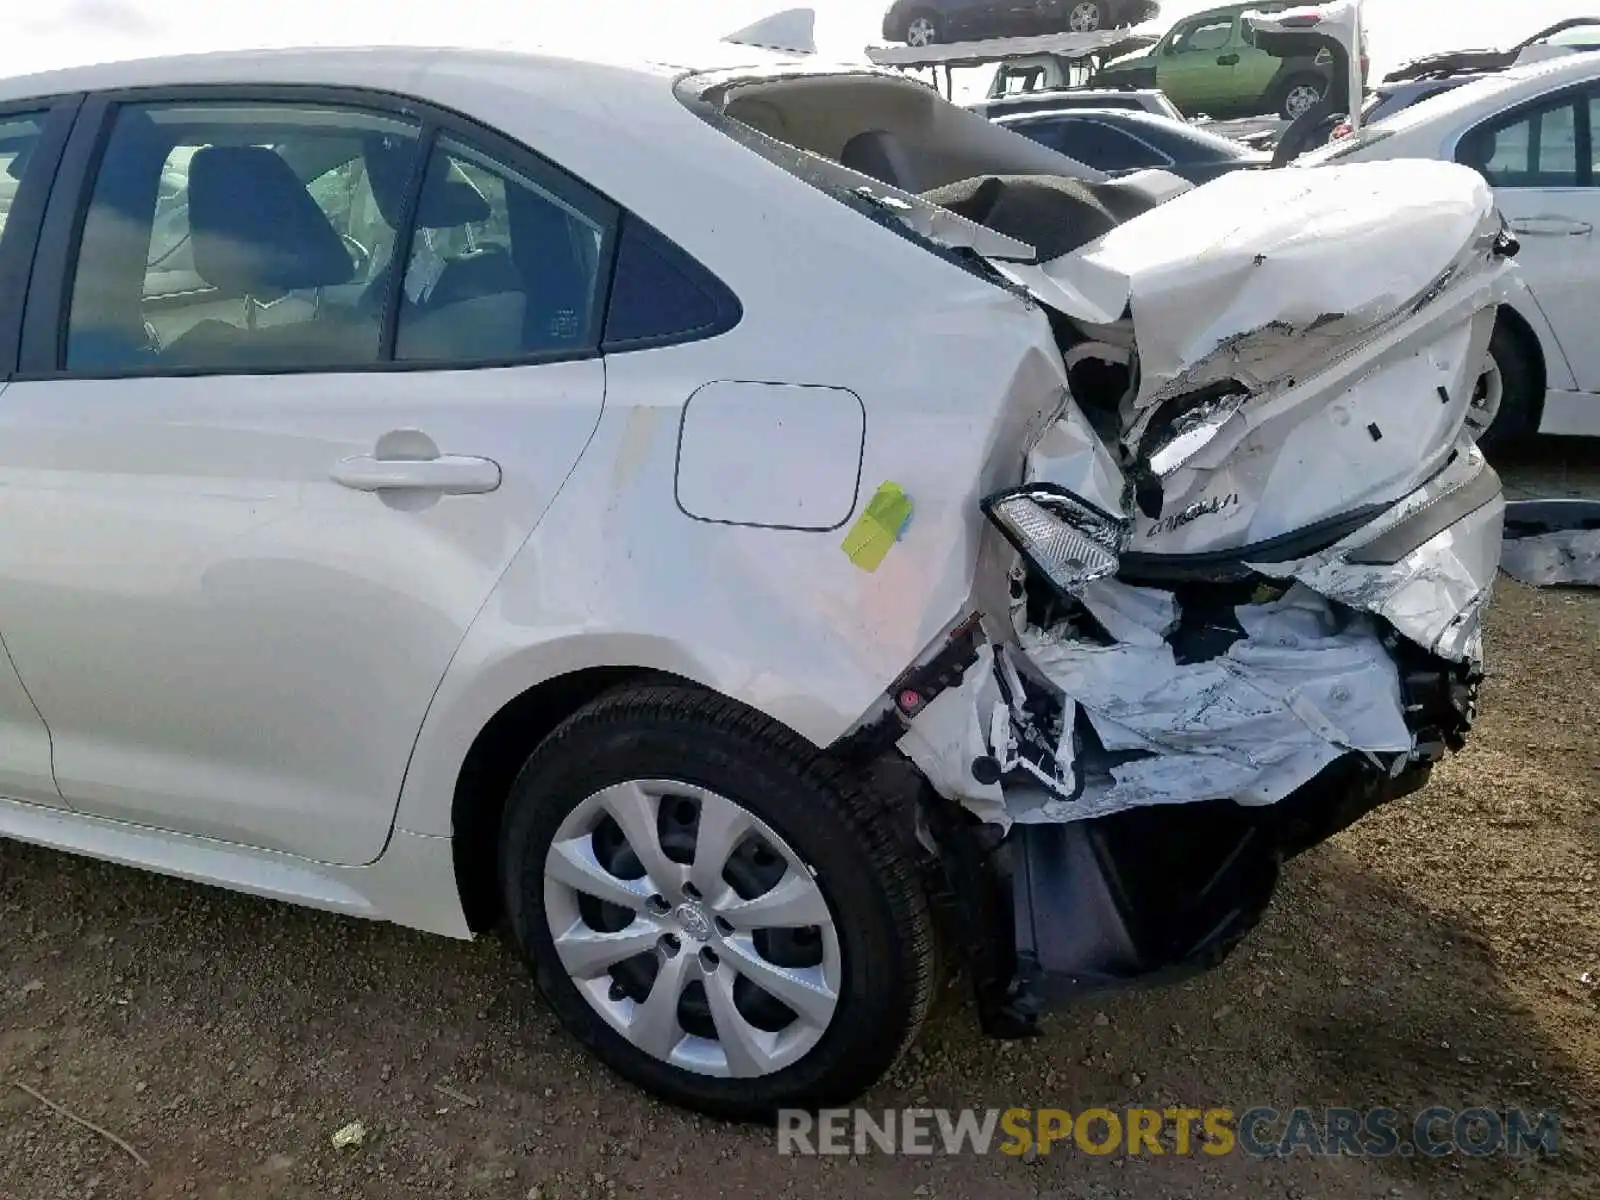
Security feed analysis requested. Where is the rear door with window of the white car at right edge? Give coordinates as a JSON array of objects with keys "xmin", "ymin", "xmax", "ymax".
[{"xmin": 1456, "ymin": 88, "xmax": 1600, "ymax": 392}]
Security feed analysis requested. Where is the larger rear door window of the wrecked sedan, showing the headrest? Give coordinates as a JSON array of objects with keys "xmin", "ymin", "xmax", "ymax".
[{"xmin": 66, "ymin": 101, "xmax": 421, "ymax": 371}]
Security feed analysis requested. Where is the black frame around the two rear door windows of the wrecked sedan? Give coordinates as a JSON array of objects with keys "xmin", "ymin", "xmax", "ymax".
[{"xmin": 20, "ymin": 83, "xmax": 626, "ymax": 381}]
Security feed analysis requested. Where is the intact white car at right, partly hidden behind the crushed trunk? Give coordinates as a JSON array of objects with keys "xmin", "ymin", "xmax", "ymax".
[{"xmin": 1294, "ymin": 54, "xmax": 1600, "ymax": 442}]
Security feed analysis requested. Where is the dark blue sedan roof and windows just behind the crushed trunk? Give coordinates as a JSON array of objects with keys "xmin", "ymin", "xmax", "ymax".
[{"xmin": 995, "ymin": 109, "xmax": 1272, "ymax": 184}]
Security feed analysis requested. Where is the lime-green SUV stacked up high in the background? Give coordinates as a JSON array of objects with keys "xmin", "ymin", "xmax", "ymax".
[{"xmin": 1091, "ymin": 0, "xmax": 1366, "ymax": 120}]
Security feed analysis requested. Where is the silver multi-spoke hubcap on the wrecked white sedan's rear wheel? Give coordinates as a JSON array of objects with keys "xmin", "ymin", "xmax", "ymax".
[{"xmin": 544, "ymin": 779, "xmax": 842, "ymax": 1078}]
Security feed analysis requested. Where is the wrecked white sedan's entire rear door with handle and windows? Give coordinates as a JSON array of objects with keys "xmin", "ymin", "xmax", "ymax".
[{"xmin": 0, "ymin": 88, "xmax": 614, "ymax": 864}]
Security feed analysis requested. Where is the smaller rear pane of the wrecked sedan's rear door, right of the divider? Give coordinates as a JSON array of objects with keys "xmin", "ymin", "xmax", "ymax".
[{"xmin": 395, "ymin": 136, "xmax": 616, "ymax": 363}]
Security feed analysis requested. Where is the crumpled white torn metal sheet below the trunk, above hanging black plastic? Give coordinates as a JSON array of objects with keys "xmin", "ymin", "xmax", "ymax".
[{"xmin": 901, "ymin": 581, "xmax": 1414, "ymax": 826}]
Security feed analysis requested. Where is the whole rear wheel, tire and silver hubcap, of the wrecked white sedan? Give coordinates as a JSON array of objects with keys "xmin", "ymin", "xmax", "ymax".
[{"xmin": 501, "ymin": 686, "xmax": 934, "ymax": 1120}]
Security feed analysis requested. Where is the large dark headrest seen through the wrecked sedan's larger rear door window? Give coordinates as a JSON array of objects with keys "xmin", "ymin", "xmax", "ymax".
[{"xmin": 189, "ymin": 146, "xmax": 355, "ymax": 296}]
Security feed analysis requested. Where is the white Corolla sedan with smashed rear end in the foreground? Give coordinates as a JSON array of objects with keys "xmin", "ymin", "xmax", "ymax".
[{"xmin": 0, "ymin": 50, "xmax": 1517, "ymax": 1115}]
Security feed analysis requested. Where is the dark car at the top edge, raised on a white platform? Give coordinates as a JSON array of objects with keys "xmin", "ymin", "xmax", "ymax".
[{"xmin": 883, "ymin": 0, "xmax": 1162, "ymax": 46}]
